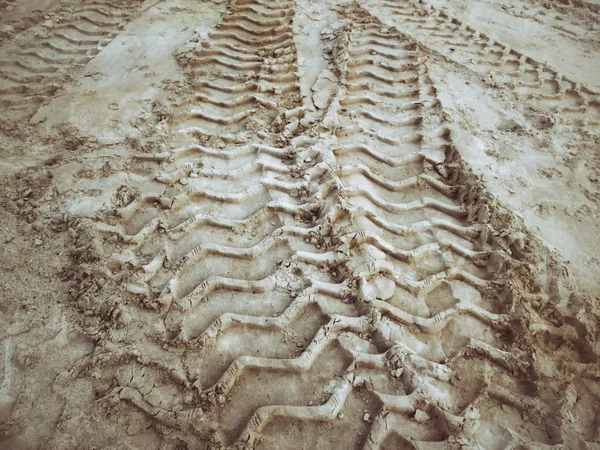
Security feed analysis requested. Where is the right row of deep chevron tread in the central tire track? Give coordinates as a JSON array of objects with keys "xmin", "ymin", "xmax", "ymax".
[{"xmin": 318, "ymin": 16, "xmax": 526, "ymax": 449}]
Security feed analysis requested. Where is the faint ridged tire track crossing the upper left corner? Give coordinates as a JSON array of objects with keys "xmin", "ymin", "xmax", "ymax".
[{"xmin": 0, "ymin": 1, "xmax": 141, "ymax": 118}]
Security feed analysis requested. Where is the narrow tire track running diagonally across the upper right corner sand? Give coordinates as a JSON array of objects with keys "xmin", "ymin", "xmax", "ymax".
[{"xmin": 366, "ymin": 0, "xmax": 600, "ymax": 129}]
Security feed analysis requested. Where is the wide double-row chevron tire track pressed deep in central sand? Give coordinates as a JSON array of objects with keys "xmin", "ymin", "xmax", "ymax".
[{"xmin": 62, "ymin": 0, "xmax": 598, "ymax": 449}]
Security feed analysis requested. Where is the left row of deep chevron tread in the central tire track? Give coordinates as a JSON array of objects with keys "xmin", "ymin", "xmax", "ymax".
[{"xmin": 88, "ymin": 2, "xmax": 354, "ymax": 445}]
